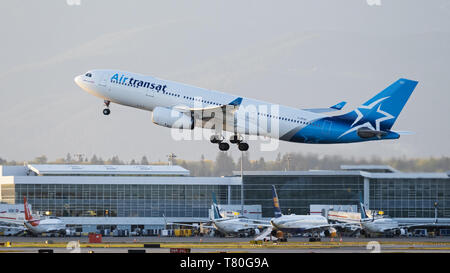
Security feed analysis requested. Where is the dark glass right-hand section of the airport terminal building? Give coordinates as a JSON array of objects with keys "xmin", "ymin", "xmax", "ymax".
[{"xmin": 235, "ymin": 165, "xmax": 450, "ymax": 222}]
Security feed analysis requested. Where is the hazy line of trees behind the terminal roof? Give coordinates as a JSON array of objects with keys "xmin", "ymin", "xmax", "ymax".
[{"xmin": 0, "ymin": 152, "xmax": 450, "ymax": 176}]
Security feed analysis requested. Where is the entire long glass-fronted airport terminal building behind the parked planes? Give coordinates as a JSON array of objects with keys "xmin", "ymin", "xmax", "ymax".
[{"xmin": 0, "ymin": 165, "xmax": 450, "ymax": 232}]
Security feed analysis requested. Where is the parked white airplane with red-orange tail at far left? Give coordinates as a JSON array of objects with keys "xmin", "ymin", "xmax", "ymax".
[{"xmin": 23, "ymin": 196, "xmax": 66, "ymax": 235}]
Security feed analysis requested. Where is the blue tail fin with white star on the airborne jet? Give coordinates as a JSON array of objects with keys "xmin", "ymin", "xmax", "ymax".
[{"xmin": 335, "ymin": 78, "xmax": 418, "ymax": 131}]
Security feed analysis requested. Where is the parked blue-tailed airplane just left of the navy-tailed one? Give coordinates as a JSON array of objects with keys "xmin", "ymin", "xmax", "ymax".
[{"xmin": 166, "ymin": 192, "xmax": 271, "ymax": 237}]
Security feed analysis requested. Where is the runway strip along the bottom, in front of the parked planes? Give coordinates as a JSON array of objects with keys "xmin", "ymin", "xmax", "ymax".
[{"xmin": 0, "ymin": 237, "xmax": 450, "ymax": 253}]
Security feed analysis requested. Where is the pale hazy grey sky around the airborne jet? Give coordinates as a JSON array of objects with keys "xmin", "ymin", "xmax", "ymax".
[{"xmin": 0, "ymin": 0, "xmax": 450, "ymax": 161}]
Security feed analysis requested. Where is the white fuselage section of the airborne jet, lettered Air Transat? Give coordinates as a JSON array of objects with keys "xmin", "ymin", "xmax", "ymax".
[{"xmin": 75, "ymin": 70, "xmax": 325, "ymax": 139}]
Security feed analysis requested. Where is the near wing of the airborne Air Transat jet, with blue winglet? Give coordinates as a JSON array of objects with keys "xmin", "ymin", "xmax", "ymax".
[{"xmin": 174, "ymin": 97, "xmax": 242, "ymax": 129}]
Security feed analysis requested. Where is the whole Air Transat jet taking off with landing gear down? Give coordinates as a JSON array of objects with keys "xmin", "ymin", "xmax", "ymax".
[{"xmin": 74, "ymin": 70, "xmax": 418, "ymax": 151}]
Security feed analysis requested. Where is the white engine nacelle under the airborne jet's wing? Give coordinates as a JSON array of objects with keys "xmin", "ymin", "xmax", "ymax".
[{"xmin": 152, "ymin": 107, "xmax": 194, "ymax": 130}]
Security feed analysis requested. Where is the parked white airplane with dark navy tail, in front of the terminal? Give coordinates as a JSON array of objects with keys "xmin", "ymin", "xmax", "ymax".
[{"xmin": 256, "ymin": 185, "xmax": 344, "ymax": 241}]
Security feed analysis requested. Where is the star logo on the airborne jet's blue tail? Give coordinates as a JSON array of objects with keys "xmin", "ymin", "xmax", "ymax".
[{"xmin": 338, "ymin": 97, "xmax": 394, "ymax": 138}]
